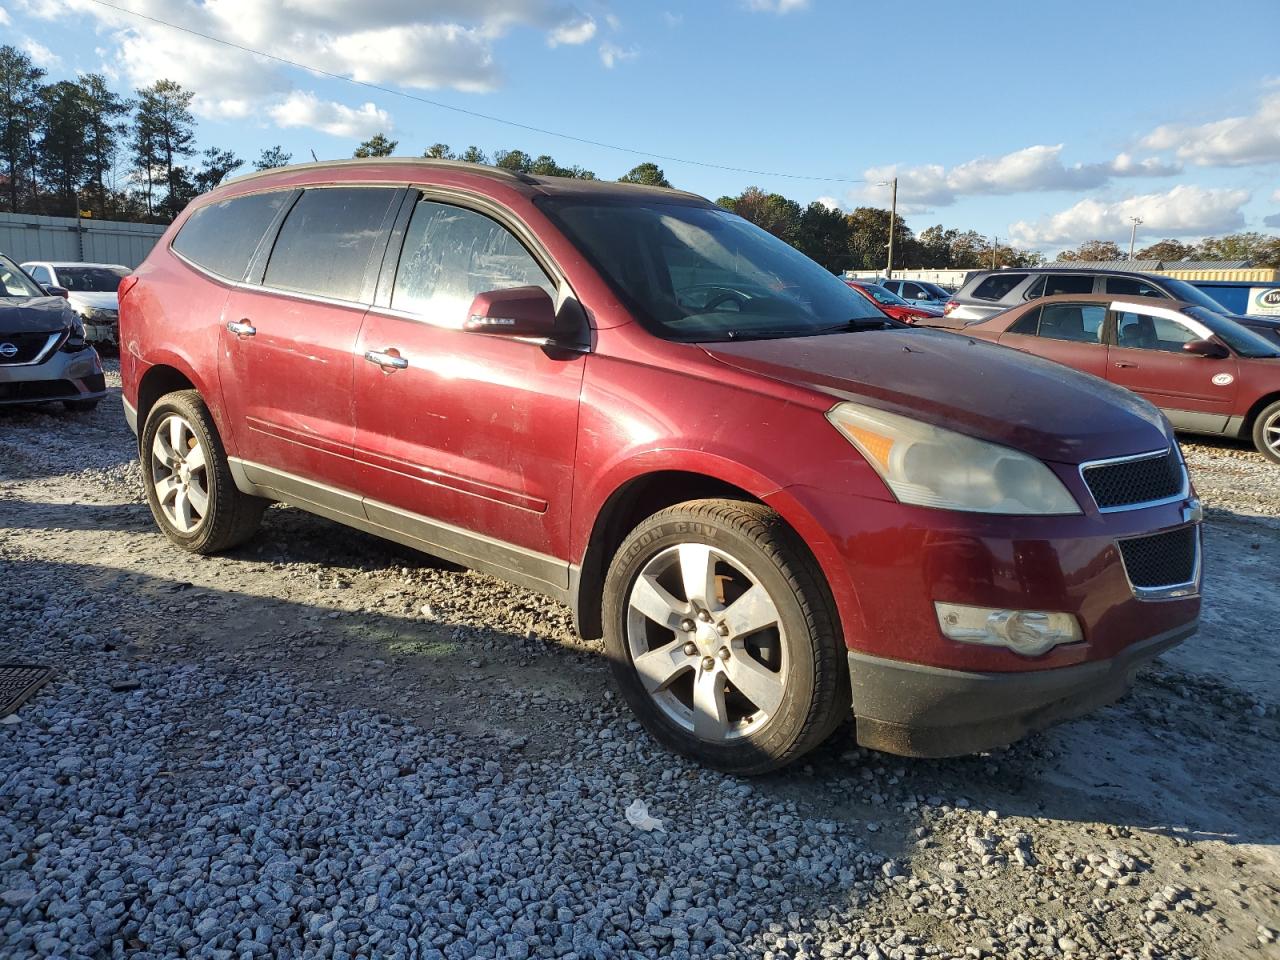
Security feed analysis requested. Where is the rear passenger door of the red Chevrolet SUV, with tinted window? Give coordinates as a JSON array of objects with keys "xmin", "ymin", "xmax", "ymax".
[{"xmin": 219, "ymin": 187, "xmax": 403, "ymax": 489}]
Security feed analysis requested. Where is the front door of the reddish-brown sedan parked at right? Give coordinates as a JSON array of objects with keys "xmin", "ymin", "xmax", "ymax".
[{"xmin": 1107, "ymin": 302, "xmax": 1239, "ymax": 433}]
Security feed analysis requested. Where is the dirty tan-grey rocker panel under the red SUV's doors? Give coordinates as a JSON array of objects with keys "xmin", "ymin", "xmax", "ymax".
[{"xmin": 227, "ymin": 457, "xmax": 571, "ymax": 603}]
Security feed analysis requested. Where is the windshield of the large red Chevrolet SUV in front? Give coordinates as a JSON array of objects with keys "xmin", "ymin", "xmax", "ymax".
[{"xmin": 539, "ymin": 197, "xmax": 899, "ymax": 343}]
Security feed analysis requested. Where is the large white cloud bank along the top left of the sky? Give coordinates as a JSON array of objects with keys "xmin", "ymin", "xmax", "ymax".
[{"xmin": 14, "ymin": 0, "xmax": 631, "ymax": 129}]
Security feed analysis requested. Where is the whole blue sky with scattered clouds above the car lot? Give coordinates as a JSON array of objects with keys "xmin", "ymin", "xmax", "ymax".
[{"xmin": 0, "ymin": 0, "xmax": 1280, "ymax": 253}]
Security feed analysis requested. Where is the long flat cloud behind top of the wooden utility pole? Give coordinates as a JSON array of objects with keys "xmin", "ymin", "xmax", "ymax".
[{"xmin": 863, "ymin": 143, "xmax": 1180, "ymax": 207}]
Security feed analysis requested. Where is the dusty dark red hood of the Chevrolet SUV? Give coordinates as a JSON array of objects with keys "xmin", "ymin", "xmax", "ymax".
[{"xmin": 701, "ymin": 329, "xmax": 1170, "ymax": 463}]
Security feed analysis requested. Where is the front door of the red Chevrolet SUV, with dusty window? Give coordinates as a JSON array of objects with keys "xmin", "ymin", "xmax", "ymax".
[{"xmin": 355, "ymin": 195, "xmax": 586, "ymax": 586}]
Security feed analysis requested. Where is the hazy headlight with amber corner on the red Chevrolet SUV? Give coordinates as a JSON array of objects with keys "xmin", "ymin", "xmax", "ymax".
[{"xmin": 827, "ymin": 403, "xmax": 1080, "ymax": 515}]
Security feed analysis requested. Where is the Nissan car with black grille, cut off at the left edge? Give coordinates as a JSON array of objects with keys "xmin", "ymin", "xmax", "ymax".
[{"xmin": 0, "ymin": 255, "xmax": 106, "ymax": 411}]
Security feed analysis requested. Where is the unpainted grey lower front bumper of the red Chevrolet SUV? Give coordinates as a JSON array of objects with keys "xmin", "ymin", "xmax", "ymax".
[{"xmin": 849, "ymin": 618, "xmax": 1199, "ymax": 756}]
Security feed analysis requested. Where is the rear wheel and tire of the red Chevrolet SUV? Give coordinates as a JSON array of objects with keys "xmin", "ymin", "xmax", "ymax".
[{"xmin": 140, "ymin": 390, "xmax": 268, "ymax": 554}]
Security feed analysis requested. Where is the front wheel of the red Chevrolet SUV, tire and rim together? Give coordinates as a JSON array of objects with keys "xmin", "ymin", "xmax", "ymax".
[{"xmin": 603, "ymin": 499, "xmax": 851, "ymax": 774}]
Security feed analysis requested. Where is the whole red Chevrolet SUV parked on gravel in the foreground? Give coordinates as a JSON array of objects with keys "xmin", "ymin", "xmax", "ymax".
[{"xmin": 120, "ymin": 160, "xmax": 1201, "ymax": 773}]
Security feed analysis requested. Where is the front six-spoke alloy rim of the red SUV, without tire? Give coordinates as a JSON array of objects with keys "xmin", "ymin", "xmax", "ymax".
[{"xmin": 626, "ymin": 543, "xmax": 788, "ymax": 741}]
